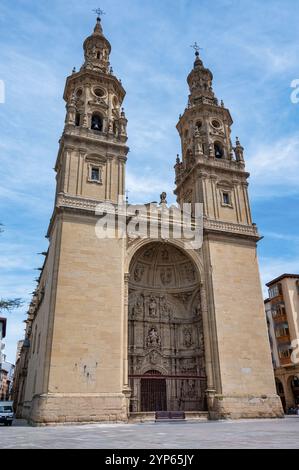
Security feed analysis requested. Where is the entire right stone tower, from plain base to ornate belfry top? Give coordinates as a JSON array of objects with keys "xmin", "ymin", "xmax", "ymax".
[{"xmin": 175, "ymin": 50, "xmax": 282, "ymax": 418}]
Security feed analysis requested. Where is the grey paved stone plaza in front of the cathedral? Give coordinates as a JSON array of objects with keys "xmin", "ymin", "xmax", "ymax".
[{"xmin": 0, "ymin": 416, "xmax": 299, "ymax": 449}]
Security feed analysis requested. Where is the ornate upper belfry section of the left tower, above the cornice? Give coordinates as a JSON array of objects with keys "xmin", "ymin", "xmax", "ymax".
[{"xmin": 56, "ymin": 18, "xmax": 129, "ymax": 205}]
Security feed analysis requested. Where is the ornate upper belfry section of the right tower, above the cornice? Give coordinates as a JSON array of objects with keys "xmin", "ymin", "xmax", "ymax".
[{"xmin": 175, "ymin": 51, "xmax": 248, "ymax": 224}]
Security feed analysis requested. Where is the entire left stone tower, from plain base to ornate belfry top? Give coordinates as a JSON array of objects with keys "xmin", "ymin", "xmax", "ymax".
[{"xmin": 22, "ymin": 18, "xmax": 129, "ymax": 424}]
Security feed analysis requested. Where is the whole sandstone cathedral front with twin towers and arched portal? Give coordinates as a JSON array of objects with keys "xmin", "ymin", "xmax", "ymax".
[{"xmin": 15, "ymin": 19, "xmax": 282, "ymax": 425}]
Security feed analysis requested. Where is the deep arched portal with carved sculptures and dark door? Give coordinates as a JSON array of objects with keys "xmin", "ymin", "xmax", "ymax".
[{"xmin": 129, "ymin": 242, "xmax": 207, "ymax": 412}]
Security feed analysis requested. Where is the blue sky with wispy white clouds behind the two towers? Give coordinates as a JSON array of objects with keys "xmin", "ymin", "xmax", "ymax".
[{"xmin": 0, "ymin": 0, "xmax": 299, "ymax": 362}]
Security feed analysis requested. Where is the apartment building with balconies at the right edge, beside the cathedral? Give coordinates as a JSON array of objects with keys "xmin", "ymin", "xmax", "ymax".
[{"xmin": 265, "ymin": 274, "xmax": 299, "ymax": 411}]
